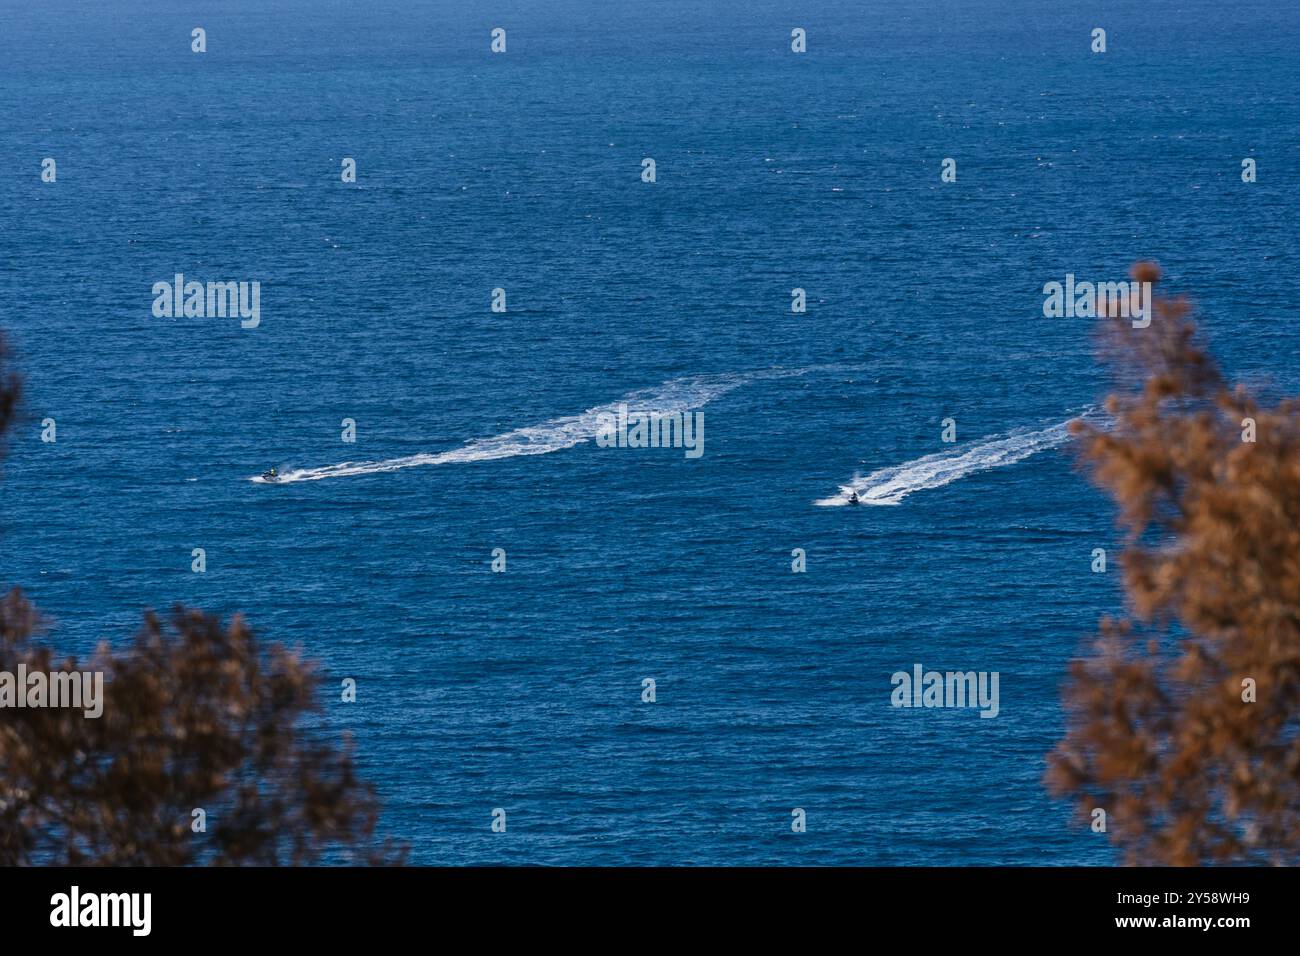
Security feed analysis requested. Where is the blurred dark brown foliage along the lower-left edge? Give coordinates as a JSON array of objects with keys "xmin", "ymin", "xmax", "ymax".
[{"xmin": 0, "ymin": 339, "xmax": 402, "ymax": 865}]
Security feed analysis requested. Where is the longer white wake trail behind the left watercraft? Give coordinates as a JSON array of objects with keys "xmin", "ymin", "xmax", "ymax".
[{"xmin": 250, "ymin": 365, "xmax": 846, "ymax": 484}]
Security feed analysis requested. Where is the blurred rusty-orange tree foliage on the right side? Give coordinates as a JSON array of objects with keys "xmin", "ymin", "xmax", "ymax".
[{"xmin": 1048, "ymin": 263, "xmax": 1300, "ymax": 865}]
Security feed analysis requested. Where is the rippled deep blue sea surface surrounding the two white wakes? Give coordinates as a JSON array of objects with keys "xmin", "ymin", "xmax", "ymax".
[{"xmin": 0, "ymin": 0, "xmax": 1300, "ymax": 865}]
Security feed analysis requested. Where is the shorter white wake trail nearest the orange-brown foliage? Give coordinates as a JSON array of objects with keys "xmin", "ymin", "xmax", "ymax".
[{"xmin": 813, "ymin": 408, "xmax": 1093, "ymax": 507}]
